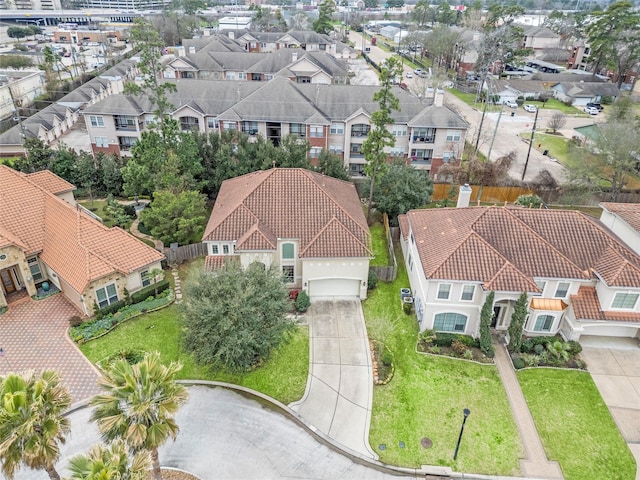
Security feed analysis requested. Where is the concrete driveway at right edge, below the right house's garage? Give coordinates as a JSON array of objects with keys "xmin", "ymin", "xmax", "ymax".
[{"xmin": 580, "ymin": 337, "xmax": 640, "ymax": 480}]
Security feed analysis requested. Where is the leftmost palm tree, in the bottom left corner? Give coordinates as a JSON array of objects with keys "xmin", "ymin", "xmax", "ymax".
[{"xmin": 0, "ymin": 370, "xmax": 71, "ymax": 480}]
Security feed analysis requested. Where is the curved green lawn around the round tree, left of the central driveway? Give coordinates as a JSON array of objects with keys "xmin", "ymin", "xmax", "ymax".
[{"xmin": 80, "ymin": 305, "xmax": 309, "ymax": 404}]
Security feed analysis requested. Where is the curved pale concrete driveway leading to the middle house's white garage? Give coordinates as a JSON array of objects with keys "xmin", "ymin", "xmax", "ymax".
[{"xmin": 290, "ymin": 298, "xmax": 377, "ymax": 459}]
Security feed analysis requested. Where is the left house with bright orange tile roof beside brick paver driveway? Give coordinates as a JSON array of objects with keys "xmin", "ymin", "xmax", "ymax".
[{"xmin": 0, "ymin": 165, "xmax": 164, "ymax": 315}]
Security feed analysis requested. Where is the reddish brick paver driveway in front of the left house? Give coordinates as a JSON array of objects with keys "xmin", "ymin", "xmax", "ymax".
[{"xmin": 0, "ymin": 294, "xmax": 99, "ymax": 403}]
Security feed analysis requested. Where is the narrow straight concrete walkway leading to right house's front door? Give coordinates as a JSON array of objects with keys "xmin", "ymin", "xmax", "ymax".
[{"xmin": 493, "ymin": 340, "xmax": 564, "ymax": 479}]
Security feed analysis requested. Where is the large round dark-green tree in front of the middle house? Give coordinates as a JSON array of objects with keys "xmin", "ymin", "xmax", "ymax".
[{"xmin": 183, "ymin": 261, "xmax": 293, "ymax": 371}]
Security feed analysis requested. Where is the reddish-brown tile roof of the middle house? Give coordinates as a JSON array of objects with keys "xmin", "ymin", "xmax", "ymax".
[{"xmin": 203, "ymin": 168, "xmax": 372, "ymax": 258}]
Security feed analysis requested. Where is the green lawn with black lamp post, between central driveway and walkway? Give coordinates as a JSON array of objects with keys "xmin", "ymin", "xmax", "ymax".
[{"xmin": 364, "ymin": 249, "xmax": 523, "ymax": 475}]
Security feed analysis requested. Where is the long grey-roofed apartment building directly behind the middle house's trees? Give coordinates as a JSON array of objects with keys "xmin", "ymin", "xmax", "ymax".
[{"xmin": 84, "ymin": 78, "xmax": 469, "ymax": 175}]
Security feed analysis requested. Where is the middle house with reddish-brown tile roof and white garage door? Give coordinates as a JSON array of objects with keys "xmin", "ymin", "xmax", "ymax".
[{"xmin": 202, "ymin": 168, "xmax": 373, "ymax": 300}]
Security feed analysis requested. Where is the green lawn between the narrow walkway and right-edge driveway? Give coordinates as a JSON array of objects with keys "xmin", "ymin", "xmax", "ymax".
[{"xmin": 518, "ymin": 369, "xmax": 636, "ymax": 480}]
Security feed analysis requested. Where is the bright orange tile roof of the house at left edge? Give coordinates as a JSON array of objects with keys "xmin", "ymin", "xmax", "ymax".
[{"xmin": 0, "ymin": 165, "xmax": 164, "ymax": 293}]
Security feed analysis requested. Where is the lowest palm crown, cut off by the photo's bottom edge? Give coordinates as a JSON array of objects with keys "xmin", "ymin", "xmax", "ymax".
[{"xmin": 68, "ymin": 438, "xmax": 151, "ymax": 480}]
